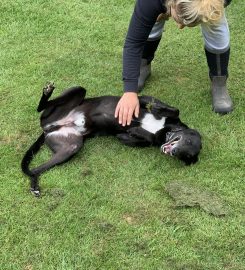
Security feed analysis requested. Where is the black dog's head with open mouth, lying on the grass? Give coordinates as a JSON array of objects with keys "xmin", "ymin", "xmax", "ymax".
[{"xmin": 161, "ymin": 128, "xmax": 202, "ymax": 165}]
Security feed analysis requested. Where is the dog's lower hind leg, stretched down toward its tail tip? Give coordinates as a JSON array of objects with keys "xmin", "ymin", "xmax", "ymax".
[{"xmin": 31, "ymin": 135, "xmax": 83, "ymax": 196}]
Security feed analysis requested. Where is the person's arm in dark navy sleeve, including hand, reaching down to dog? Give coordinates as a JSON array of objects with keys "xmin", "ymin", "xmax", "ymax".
[{"xmin": 115, "ymin": 0, "xmax": 167, "ymax": 126}]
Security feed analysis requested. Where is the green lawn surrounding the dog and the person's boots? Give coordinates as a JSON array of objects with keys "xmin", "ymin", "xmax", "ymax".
[{"xmin": 0, "ymin": 0, "xmax": 245, "ymax": 270}]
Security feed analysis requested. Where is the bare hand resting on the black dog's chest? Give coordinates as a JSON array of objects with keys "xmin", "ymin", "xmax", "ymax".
[{"xmin": 115, "ymin": 92, "xmax": 140, "ymax": 126}]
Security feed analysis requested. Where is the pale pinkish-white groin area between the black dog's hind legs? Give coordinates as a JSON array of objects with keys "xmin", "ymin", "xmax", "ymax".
[{"xmin": 43, "ymin": 110, "xmax": 87, "ymax": 137}]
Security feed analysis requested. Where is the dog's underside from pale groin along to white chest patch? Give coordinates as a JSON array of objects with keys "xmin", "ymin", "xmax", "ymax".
[{"xmin": 43, "ymin": 106, "xmax": 166, "ymax": 137}]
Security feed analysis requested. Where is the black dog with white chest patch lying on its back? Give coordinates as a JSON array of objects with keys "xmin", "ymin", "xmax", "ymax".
[{"xmin": 21, "ymin": 83, "xmax": 201, "ymax": 196}]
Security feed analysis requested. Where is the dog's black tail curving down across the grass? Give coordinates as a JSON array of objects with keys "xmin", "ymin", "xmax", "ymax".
[{"xmin": 21, "ymin": 133, "xmax": 45, "ymax": 177}]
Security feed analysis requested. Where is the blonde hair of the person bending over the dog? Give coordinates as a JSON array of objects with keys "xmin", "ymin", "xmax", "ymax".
[{"xmin": 168, "ymin": 0, "xmax": 224, "ymax": 26}]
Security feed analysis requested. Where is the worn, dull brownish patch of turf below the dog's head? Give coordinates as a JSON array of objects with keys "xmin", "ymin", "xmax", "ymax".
[{"xmin": 165, "ymin": 181, "xmax": 229, "ymax": 217}]
